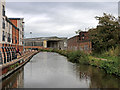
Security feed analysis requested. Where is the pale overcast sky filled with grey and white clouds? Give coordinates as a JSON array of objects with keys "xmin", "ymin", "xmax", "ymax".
[{"xmin": 6, "ymin": 1, "xmax": 118, "ymax": 38}]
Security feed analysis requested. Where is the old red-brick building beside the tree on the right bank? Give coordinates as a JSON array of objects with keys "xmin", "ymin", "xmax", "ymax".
[{"xmin": 67, "ymin": 32, "xmax": 92, "ymax": 53}]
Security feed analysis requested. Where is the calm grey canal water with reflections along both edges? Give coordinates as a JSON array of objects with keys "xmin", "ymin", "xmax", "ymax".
[{"xmin": 2, "ymin": 52, "xmax": 120, "ymax": 88}]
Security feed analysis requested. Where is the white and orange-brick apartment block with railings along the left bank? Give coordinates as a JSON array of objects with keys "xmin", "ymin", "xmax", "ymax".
[{"xmin": 0, "ymin": 0, "xmax": 24, "ymax": 64}]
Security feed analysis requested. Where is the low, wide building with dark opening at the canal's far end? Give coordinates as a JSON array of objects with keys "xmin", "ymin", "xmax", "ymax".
[{"xmin": 24, "ymin": 37, "xmax": 67, "ymax": 50}]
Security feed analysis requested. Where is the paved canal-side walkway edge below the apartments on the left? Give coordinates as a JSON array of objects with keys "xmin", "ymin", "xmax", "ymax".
[{"xmin": 0, "ymin": 51, "xmax": 38, "ymax": 80}]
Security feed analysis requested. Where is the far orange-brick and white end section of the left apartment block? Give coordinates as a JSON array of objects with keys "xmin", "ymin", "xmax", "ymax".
[{"xmin": 9, "ymin": 18, "xmax": 24, "ymax": 52}]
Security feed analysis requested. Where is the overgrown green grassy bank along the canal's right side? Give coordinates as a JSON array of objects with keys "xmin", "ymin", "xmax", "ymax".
[{"xmin": 40, "ymin": 49, "xmax": 120, "ymax": 77}]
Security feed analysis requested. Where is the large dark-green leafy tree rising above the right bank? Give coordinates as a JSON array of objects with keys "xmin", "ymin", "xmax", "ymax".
[{"xmin": 89, "ymin": 13, "xmax": 120, "ymax": 52}]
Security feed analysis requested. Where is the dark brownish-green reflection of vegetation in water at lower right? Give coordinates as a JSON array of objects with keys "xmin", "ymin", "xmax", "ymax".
[{"xmin": 76, "ymin": 65, "xmax": 120, "ymax": 88}]
